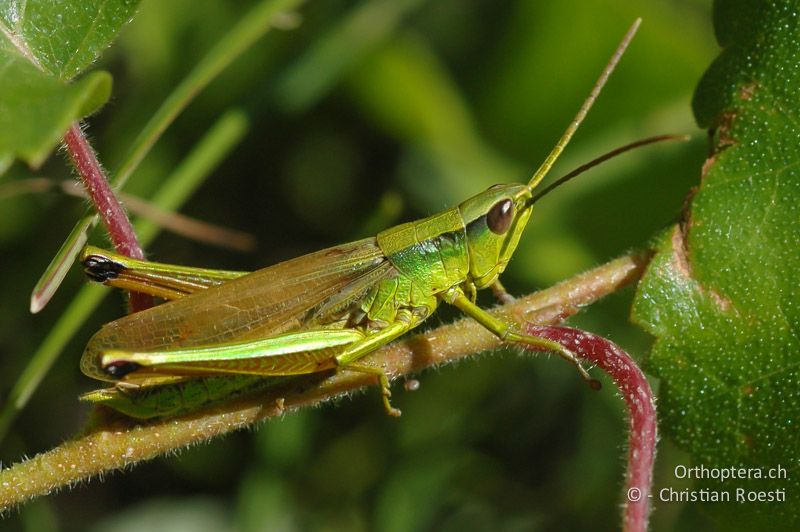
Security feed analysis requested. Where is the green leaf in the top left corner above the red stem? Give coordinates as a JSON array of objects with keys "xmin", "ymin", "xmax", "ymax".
[{"xmin": 0, "ymin": 0, "xmax": 138, "ymax": 168}]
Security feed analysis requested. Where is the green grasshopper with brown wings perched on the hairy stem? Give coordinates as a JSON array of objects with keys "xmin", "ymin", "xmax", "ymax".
[{"xmin": 81, "ymin": 20, "xmax": 640, "ymax": 418}]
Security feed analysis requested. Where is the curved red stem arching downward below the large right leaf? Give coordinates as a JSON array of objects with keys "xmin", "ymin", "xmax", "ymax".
[{"xmin": 526, "ymin": 325, "xmax": 658, "ymax": 532}]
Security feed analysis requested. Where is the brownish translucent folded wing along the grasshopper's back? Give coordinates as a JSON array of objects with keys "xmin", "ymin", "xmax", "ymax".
[{"xmin": 81, "ymin": 238, "xmax": 394, "ymax": 380}]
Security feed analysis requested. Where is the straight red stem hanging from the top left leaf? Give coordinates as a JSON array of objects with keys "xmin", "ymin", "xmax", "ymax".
[{"xmin": 64, "ymin": 122, "xmax": 153, "ymax": 312}]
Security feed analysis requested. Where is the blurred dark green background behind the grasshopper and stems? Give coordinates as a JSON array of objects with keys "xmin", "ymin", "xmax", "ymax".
[{"xmin": 0, "ymin": 0, "xmax": 717, "ymax": 532}]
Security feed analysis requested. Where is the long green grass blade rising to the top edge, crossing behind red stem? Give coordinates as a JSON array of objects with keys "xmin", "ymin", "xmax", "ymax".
[{"xmin": 31, "ymin": 0, "xmax": 303, "ymax": 310}]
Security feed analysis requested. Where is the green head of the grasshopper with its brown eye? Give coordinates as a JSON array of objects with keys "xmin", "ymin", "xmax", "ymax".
[{"xmin": 458, "ymin": 184, "xmax": 532, "ymax": 288}]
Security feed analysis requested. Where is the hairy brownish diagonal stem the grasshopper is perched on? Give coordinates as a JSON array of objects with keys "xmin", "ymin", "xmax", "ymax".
[{"xmin": 0, "ymin": 254, "xmax": 649, "ymax": 508}]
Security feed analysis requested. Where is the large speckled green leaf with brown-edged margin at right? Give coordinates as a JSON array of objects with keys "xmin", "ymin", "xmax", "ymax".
[{"xmin": 634, "ymin": 0, "xmax": 800, "ymax": 529}]
